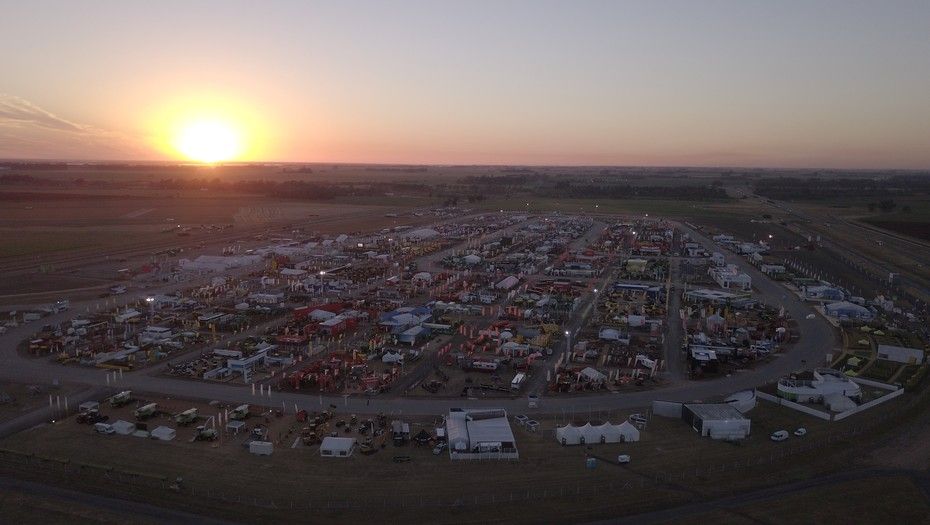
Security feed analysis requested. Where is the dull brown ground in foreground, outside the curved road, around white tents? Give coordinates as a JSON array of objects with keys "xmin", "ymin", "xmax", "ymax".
[{"xmin": 0, "ymin": 388, "xmax": 904, "ymax": 522}]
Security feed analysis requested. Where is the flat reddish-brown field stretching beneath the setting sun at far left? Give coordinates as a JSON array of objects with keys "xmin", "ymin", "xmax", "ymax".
[{"xmin": 0, "ymin": 192, "xmax": 410, "ymax": 257}]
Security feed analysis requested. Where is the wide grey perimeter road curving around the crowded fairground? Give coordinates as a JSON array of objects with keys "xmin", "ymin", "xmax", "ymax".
[{"xmin": 0, "ymin": 220, "xmax": 836, "ymax": 415}]
